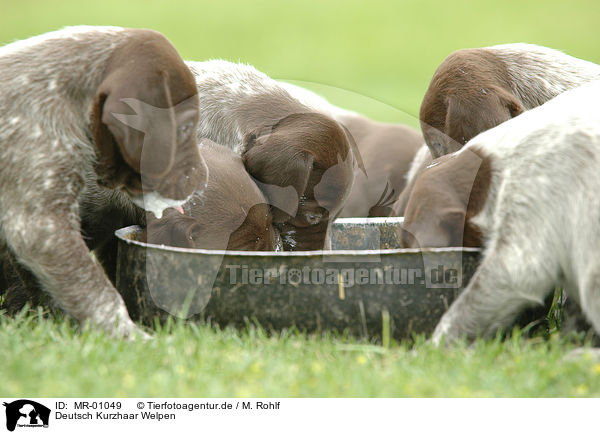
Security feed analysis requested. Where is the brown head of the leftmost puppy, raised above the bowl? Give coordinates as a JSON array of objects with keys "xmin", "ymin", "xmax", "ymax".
[{"xmin": 92, "ymin": 29, "xmax": 201, "ymax": 199}]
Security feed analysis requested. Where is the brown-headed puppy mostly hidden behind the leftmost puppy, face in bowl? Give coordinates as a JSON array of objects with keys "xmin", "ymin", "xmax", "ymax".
[{"xmin": 0, "ymin": 139, "xmax": 282, "ymax": 314}]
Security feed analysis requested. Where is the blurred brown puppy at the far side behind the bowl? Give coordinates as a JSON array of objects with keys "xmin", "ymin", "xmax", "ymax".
[{"xmin": 281, "ymin": 83, "xmax": 423, "ymax": 217}]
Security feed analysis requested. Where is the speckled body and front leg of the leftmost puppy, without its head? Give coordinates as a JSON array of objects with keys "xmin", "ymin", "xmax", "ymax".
[{"xmin": 0, "ymin": 26, "xmax": 151, "ymax": 335}]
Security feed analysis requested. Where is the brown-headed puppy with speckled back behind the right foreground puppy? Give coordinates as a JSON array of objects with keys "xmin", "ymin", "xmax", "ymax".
[{"xmin": 393, "ymin": 43, "xmax": 600, "ymax": 215}]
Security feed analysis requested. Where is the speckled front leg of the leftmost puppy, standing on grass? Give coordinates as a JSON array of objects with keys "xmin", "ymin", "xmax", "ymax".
[{"xmin": 3, "ymin": 213, "xmax": 145, "ymax": 337}]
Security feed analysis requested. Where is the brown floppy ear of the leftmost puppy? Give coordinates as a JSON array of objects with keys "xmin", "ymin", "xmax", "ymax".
[{"xmin": 93, "ymin": 72, "xmax": 182, "ymax": 178}]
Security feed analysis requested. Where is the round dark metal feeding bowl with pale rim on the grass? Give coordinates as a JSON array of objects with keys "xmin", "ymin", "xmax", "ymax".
[{"xmin": 116, "ymin": 218, "xmax": 480, "ymax": 339}]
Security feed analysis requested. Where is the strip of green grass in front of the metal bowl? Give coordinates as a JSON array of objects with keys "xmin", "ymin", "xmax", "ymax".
[{"xmin": 0, "ymin": 311, "xmax": 600, "ymax": 397}]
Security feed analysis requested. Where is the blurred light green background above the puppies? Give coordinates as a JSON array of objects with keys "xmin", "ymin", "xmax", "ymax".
[{"xmin": 0, "ymin": 0, "xmax": 600, "ymax": 125}]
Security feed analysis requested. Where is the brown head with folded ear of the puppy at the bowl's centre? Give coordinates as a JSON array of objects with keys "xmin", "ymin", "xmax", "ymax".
[{"xmin": 243, "ymin": 113, "xmax": 354, "ymax": 250}]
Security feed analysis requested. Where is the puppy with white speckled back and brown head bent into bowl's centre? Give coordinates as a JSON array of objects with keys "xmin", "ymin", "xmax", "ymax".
[{"xmin": 187, "ymin": 60, "xmax": 358, "ymax": 250}]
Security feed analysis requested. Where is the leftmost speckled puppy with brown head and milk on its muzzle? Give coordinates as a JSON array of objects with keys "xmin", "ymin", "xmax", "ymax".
[{"xmin": 0, "ymin": 26, "xmax": 205, "ymax": 335}]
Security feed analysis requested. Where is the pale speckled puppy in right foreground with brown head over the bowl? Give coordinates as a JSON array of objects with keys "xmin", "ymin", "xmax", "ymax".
[{"xmin": 405, "ymin": 81, "xmax": 600, "ymax": 342}]
